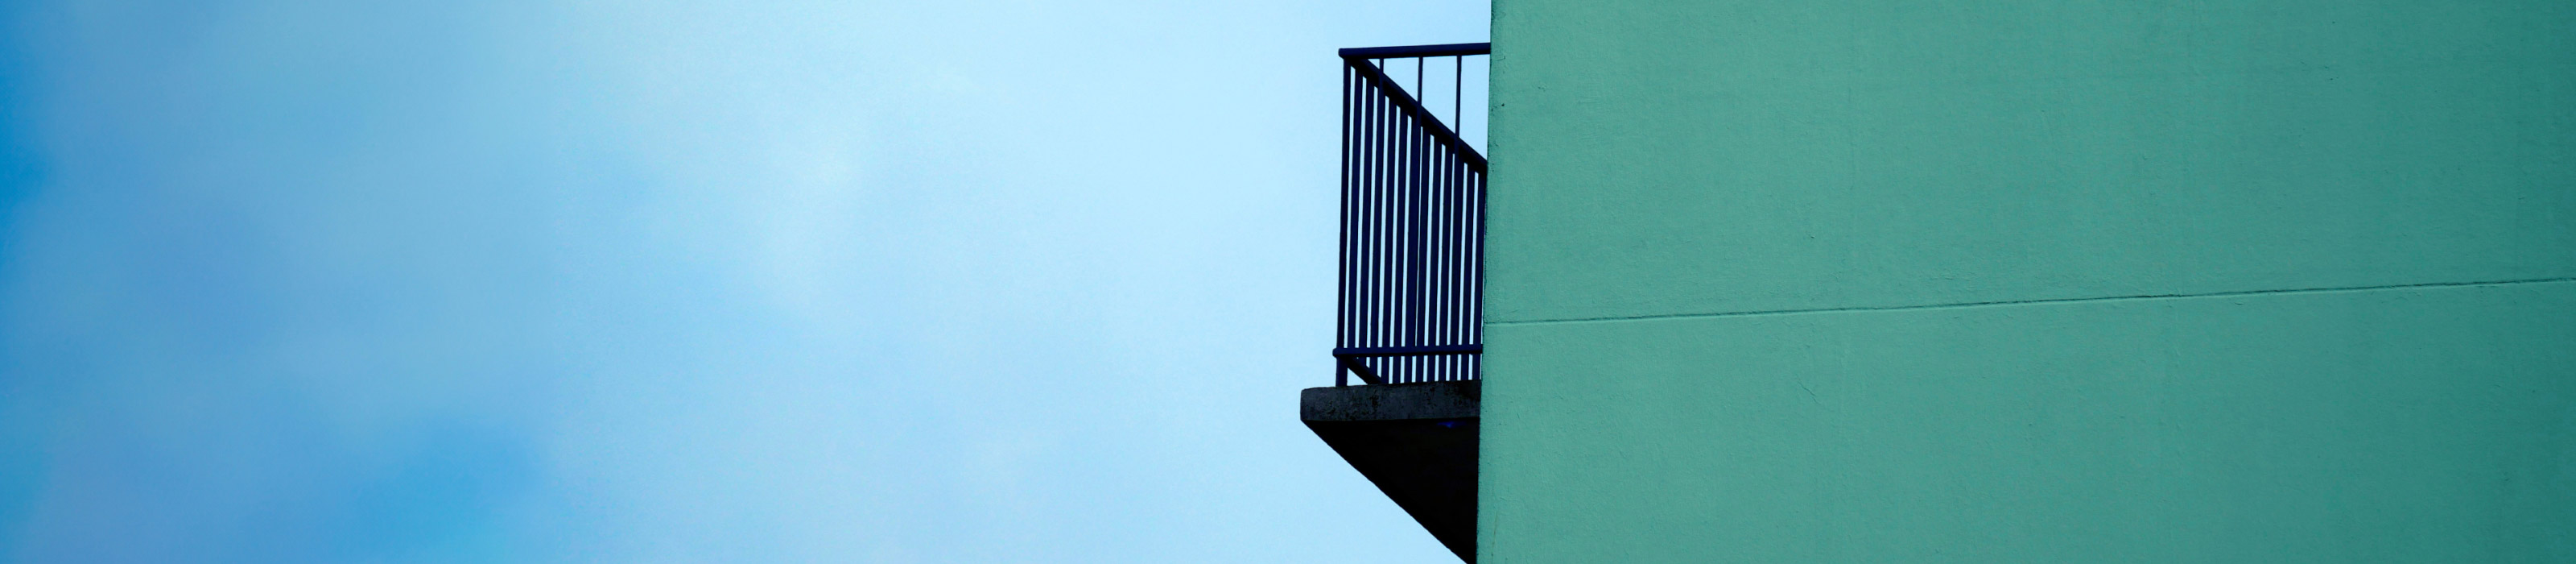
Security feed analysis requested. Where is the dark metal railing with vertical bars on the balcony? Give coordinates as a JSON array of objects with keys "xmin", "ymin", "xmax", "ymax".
[{"xmin": 1331, "ymin": 44, "xmax": 1492, "ymax": 386}]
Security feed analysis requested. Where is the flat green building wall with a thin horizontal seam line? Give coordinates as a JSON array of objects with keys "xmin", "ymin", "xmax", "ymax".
[{"xmin": 1479, "ymin": 0, "xmax": 2576, "ymax": 564}]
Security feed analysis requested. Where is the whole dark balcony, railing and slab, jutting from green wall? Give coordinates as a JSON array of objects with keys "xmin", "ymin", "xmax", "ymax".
[{"xmin": 1301, "ymin": 44, "xmax": 1492, "ymax": 562}]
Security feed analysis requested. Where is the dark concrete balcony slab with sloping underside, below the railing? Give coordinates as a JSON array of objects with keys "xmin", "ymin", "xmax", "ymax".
[{"xmin": 1301, "ymin": 381, "xmax": 1481, "ymax": 562}]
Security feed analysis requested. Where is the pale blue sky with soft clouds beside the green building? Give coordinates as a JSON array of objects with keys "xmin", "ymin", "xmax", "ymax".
[{"xmin": 0, "ymin": 0, "xmax": 1486, "ymax": 562}]
